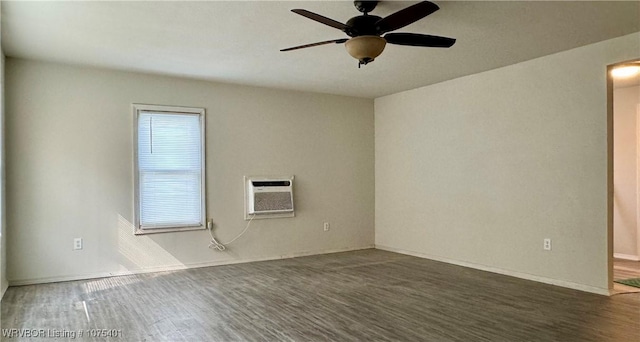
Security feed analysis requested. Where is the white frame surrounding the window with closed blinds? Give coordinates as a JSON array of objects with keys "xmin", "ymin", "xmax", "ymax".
[{"xmin": 131, "ymin": 103, "xmax": 207, "ymax": 235}]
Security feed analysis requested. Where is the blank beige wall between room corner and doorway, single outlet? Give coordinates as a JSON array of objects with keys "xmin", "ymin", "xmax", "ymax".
[{"xmin": 375, "ymin": 33, "xmax": 640, "ymax": 293}]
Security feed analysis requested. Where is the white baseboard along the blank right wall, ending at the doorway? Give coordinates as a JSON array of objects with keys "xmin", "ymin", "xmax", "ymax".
[{"xmin": 376, "ymin": 245, "xmax": 612, "ymax": 296}]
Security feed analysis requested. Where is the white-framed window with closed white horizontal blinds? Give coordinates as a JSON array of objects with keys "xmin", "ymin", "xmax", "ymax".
[{"xmin": 133, "ymin": 104, "xmax": 206, "ymax": 234}]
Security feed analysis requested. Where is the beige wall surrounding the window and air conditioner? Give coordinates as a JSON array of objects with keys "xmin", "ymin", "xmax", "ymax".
[{"xmin": 6, "ymin": 58, "xmax": 374, "ymax": 284}]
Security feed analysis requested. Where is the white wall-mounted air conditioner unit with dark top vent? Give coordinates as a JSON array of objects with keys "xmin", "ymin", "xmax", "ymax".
[{"xmin": 244, "ymin": 176, "xmax": 295, "ymax": 219}]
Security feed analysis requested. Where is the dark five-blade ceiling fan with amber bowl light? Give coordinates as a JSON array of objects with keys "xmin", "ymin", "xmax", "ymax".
[{"xmin": 280, "ymin": 0, "xmax": 456, "ymax": 67}]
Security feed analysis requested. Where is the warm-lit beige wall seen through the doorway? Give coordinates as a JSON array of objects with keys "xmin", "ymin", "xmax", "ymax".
[{"xmin": 613, "ymin": 87, "xmax": 640, "ymax": 259}]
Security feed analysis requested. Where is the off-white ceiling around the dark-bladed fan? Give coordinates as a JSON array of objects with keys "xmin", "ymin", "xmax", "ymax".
[{"xmin": 2, "ymin": 0, "xmax": 640, "ymax": 98}]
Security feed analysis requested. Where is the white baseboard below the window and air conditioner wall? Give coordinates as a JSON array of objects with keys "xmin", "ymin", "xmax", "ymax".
[{"xmin": 5, "ymin": 245, "xmax": 374, "ymax": 290}]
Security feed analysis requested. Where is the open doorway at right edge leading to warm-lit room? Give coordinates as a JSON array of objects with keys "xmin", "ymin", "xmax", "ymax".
[{"xmin": 607, "ymin": 60, "xmax": 640, "ymax": 294}]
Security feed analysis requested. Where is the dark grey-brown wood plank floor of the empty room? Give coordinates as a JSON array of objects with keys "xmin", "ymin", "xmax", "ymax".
[{"xmin": 2, "ymin": 250, "xmax": 640, "ymax": 342}]
